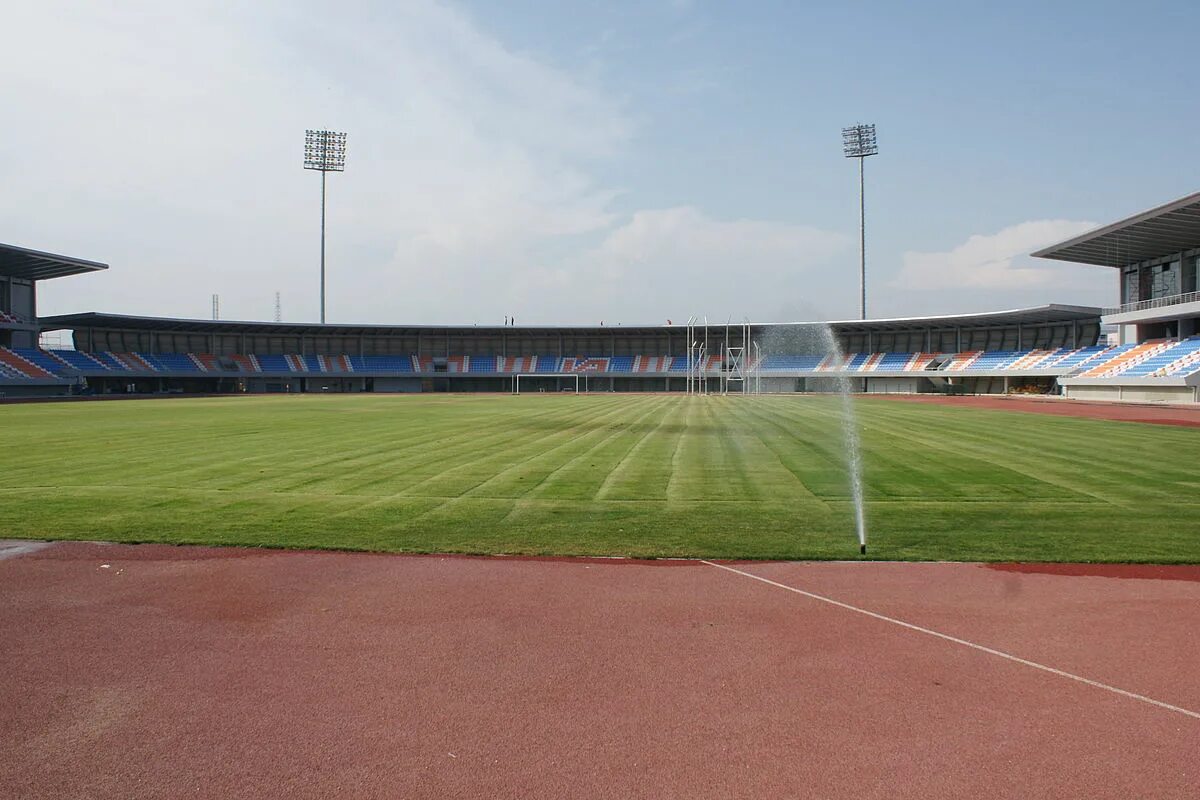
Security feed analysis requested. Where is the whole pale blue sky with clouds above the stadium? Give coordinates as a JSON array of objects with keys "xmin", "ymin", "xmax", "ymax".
[{"xmin": 0, "ymin": 0, "xmax": 1200, "ymax": 324}]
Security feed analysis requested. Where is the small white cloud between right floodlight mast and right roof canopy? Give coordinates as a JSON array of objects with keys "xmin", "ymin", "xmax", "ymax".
[{"xmin": 893, "ymin": 219, "xmax": 1096, "ymax": 289}]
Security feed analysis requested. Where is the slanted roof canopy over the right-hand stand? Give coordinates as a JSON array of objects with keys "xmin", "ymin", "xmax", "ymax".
[{"xmin": 1033, "ymin": 192, "xmax": 1200, "ymax": 267}]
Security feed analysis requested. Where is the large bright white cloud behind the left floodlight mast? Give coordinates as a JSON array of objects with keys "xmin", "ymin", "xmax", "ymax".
[{"xmin": 0, "ymin": 0, "xmax": 631, "ymax": 321}]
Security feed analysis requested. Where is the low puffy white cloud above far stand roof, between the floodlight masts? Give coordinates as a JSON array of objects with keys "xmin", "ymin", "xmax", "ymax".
[{"xmin": 379, "ymin": 206, "xmax": 850, "ymax": 324}]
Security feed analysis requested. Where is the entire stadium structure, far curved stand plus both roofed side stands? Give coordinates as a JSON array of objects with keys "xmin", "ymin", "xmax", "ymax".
[{"xmin": 7, "ymin": 194, "xmax": 1200, "ymax": 402}]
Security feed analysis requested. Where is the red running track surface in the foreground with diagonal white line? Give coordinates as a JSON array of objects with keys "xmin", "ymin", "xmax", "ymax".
[{"xmin": 0, "ymin": 543, "xmax": 1200, "ymax": 800}]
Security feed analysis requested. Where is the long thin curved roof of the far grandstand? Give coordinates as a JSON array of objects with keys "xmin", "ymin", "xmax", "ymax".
[{"xmin": 38, "ymin": 305, "xmax": 1100, "ymax": 336}]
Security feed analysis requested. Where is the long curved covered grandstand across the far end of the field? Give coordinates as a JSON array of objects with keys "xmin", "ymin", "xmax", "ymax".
[{"xmin": 0, "ymin": 306, "xmax": 1110, "ymax": 393}]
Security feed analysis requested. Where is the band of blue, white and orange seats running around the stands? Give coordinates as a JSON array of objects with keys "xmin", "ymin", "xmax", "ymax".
[{"xmin": 7, "ymin": 337, "xmax": 1200, "ymax": 380}]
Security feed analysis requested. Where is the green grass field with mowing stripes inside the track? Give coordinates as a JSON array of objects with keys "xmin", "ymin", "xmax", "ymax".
[{"xmin": 0, "ymin": 395, "xmax": 1200, "ymax": 563}]
